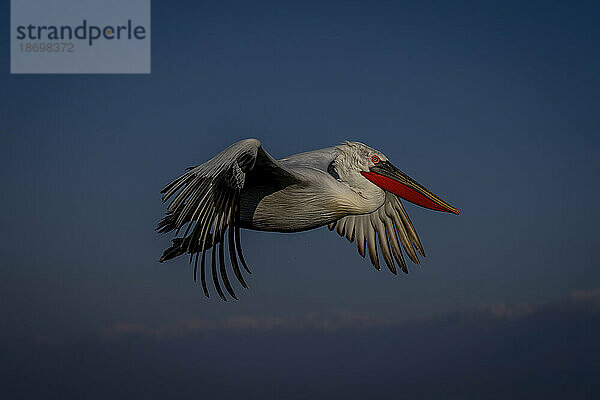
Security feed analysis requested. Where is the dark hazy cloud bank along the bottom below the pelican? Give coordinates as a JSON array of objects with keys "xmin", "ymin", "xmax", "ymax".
[{"xmin": 10, "ymin": 291, "xmax": 600, "ymax": 400}]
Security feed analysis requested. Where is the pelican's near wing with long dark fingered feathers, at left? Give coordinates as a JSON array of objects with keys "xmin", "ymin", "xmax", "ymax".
[{"xmin": 157, "ymin": 139, "xmax": 292, "ymax": 300}]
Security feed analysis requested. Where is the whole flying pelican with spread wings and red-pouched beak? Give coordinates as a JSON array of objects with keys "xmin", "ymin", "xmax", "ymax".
[{"xmin": 156, "ymin": 139, "xmax": 458, "ymax": 301}]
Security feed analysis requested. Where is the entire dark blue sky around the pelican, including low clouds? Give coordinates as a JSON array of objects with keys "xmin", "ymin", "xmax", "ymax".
[{"xmin": 0, "ymin": 1, "xmax": 600, "ymax": 399}]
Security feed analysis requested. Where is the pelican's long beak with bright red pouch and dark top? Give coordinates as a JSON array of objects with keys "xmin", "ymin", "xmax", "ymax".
[{"xmin": 361, "ymin": 161, "xmax": 458, "ymax": 215}]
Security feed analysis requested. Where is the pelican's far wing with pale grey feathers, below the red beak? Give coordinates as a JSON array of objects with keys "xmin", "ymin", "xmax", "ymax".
[{"xmin": 329, "ymin": 192, "xmax": 425, "ymax": 274}]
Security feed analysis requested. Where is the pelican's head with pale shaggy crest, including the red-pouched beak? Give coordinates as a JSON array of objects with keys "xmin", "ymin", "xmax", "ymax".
[{"xmin": 335, "ymin": 142, "xmax": 458, "ymax": 214}]
